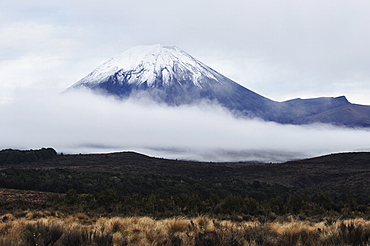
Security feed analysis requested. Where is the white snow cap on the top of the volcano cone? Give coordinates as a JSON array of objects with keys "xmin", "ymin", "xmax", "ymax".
[{"xmin": 77, "ymin": 44, "xmax": 221, "ymax": 87}]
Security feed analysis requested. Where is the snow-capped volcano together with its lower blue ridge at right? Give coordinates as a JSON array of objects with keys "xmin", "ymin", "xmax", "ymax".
[{"xmin": 67, "ymin": 44, "xmax": 370, "ymax": 127}]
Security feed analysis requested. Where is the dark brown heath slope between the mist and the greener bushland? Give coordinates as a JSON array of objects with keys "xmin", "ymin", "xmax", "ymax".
[{"xmin": 2, "ymin": 152, "xmax": 370, "ymax": 196}]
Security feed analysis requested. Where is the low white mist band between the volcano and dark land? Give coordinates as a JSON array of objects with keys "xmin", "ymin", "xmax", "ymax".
[{"xmin": 0, "ymin": 89, "xmax": 370, "ymax": 162}]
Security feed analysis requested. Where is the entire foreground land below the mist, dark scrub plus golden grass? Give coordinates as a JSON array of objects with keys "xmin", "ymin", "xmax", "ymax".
[{"xmin": 0, "ymin": 149, "xmax": 370, "ymax": 246}]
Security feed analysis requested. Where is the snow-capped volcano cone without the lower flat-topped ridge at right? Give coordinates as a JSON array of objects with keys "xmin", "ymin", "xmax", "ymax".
[{"xmin": 68, "ymin": 45, "xmax": 276, "ymax": 118}]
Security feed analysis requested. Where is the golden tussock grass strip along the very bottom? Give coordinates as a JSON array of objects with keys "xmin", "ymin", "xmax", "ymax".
[{"xmin": 0, "ymin": 211, "xmax": 370, "ymax": 246}]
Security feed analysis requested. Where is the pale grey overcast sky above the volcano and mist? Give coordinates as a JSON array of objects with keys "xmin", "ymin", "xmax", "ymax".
[{"xmin": 0, "ymin": 0, "xmax": 370, "ymax": 161}]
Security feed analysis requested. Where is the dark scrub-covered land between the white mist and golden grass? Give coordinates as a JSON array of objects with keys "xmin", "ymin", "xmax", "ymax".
[{"xmin": 0, "ymin": 149, "xmax": 370, "ymax": 220}]
